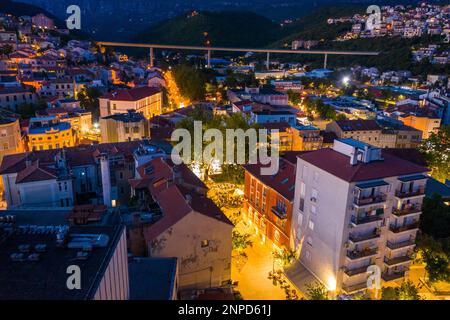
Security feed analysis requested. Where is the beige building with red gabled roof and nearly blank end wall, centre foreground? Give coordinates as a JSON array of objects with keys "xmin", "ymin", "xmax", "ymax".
[{"xmin": 130, "ymin": 158, "xmax": 233, "ymax": 290}]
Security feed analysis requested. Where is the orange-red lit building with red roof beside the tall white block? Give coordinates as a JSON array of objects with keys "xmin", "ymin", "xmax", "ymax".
[{"xmin": 243, "ymin": 152, "xmax": 298, "ymax": 248}]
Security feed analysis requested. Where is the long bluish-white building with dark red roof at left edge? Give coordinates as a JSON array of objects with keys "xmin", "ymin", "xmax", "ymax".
[{"xmin": 0, "ymin": 141, "xmax": 166, "ymax": 209}]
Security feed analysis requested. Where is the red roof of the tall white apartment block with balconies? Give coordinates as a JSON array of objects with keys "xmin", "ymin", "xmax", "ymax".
[{"xmin": 298, "ymin": 148, "xmax": 429, "ymax": 182}]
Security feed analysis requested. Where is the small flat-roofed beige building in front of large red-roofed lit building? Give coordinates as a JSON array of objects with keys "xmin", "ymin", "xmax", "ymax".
[{"xmin": 100, "ymin": 110, "xmax": 150, "ymax": 142}]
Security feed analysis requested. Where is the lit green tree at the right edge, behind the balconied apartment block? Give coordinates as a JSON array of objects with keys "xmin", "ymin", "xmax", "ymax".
[{"xmin": 419, "ymin": 125, "xmax": 450, "ymax": 182}]
